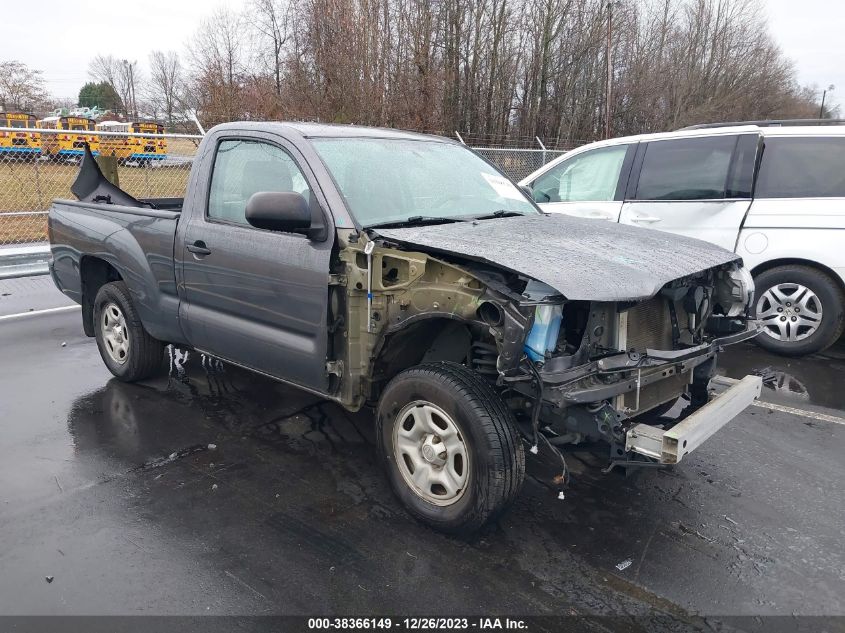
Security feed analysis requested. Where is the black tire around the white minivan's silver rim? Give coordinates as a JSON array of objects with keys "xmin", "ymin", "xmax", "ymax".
[{"xmin": 754, "ymin": 266, "xmax": 845, "ymax": 356}]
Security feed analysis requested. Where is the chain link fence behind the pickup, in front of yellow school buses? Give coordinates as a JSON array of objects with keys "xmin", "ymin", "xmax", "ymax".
[{"xmin": 0, "ymin": 127, "xmax": 564, "ymax": 246}]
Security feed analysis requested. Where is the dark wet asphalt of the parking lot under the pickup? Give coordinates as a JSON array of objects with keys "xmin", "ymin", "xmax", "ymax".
[{"xmin": 0, "ymin": 277, "xmax": 845, "ymax": 629}]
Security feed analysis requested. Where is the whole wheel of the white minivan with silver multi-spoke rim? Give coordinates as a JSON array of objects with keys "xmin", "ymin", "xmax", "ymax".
[{"xmin": 754, "ymin": 266, "xmax": 845, "ymax": 356}]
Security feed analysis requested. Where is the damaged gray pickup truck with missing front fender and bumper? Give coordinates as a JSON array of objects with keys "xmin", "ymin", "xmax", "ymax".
[{"xmin": 49, "ymin": 123, "xmax": 760, "ymax": 532}]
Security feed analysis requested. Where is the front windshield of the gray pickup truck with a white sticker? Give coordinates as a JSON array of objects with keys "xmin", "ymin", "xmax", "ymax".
[{"xmin": 313, "ymin": 138, "xmax": 539, "ymax": 227}]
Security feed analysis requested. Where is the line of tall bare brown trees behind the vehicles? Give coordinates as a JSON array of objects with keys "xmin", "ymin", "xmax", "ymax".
[{"xmin": 0, "ymin": 0, "xmax": 831, "ymax": 147}]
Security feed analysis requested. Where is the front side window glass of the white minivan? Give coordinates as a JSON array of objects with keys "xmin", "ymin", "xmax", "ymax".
[{"xmin": 531, "ymin": 145, "xmax": 628, "ymax": 204}]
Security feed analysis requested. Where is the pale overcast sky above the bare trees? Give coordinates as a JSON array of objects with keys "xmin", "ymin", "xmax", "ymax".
[{"xmin": 0, "ymin": 0, "xmax": 845, "ymax": 115}]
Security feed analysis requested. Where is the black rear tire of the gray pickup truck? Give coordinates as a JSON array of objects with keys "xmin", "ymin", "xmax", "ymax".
[{"xmin": 94, "ymin": 281, "xmax": 164, "ymax": 382}]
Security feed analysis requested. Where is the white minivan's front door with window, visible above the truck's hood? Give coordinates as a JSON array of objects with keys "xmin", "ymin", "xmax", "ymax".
[{"xmin": 528, "ymin": 143, "xmax": 636, "ymax": 222}]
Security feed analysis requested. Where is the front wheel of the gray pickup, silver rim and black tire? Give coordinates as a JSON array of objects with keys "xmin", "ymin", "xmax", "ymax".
[{"xmin": 377, "ymin": 362, "xmax": 525, "ymax": 533}]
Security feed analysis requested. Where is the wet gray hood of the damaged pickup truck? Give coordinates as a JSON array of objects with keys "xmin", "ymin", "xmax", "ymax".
[{"xmin": 374, "ymin": 214, "xmax": 740, "ymax": 301}]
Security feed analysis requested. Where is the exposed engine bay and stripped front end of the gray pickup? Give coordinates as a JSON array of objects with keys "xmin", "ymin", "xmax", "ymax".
[{"xmin": 329, "ymin": 212, "xmax": 757, "ymax": 478}]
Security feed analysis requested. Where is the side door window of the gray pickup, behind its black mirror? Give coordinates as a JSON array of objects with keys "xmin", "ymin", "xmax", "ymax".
[{"xmin": 208, "ymin": 140, "xmax": 310, "ymax": 224}]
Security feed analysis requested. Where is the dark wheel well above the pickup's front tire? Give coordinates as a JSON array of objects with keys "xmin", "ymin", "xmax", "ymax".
[{"xmin": 371, "ymin": 317, "xmax": 472, "ymax": 398}]
